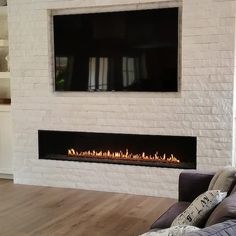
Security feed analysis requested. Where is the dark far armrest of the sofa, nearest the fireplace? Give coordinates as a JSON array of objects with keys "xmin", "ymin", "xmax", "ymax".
[{"xmin": 179, "ymin": 171, "xmax": 214, "ymax": 202}]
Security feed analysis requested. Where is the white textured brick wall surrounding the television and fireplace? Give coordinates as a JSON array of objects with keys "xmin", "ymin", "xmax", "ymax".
[{"xmin": 9, "ymin": 0, "xmax": 235, "ymax": 197}]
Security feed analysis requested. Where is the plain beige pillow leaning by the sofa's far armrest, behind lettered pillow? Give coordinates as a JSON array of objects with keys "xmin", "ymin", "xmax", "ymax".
[{"xmin": 208, "ymin": 167, "xmax": 236, "ymax": 192}]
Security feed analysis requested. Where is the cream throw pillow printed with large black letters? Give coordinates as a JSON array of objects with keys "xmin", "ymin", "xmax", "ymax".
[{"xmin": 171, "ymin": 190, "xmax": 227, "ymax": 226}]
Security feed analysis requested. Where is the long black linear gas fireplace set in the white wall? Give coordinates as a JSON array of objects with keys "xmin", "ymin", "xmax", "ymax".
[{"xmin": 38, "ymin": 130, "xmax": 196, "ymax": 169}]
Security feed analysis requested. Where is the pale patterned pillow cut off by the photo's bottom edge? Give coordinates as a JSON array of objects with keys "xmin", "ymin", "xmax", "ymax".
[{"xmin": 140, "ymin": 225, "xmax": 199, "ymax": 236}]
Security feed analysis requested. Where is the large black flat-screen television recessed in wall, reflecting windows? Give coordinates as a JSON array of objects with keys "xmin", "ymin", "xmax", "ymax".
[{"xmin": 53, "ymin": 8, "xmax": 179, "ymax": 92}]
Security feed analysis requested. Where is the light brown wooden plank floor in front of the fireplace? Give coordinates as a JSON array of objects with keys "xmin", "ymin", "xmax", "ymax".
[{"xmin": 0, "ymin": 179, "xmax": 175, "ymax": 236}]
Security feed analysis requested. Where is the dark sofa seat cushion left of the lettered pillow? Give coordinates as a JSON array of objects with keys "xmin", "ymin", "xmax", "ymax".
[{"xmin": 151, "ymin": 202, "xmax": 190, "ymax": 229}]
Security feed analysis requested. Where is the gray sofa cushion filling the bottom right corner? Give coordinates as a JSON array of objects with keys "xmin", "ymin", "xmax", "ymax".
[{"xmin": 184, "ymin": 220, "xmax": 236, "ymax": 236}]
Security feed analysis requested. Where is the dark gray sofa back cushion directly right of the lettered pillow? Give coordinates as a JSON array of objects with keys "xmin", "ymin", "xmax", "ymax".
[{"xmin": 206, "ymin": 192, "xmax": 236, "ymax": 226}]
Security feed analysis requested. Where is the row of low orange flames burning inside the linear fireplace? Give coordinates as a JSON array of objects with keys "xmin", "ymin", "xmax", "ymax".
[{"xmin": 68, "ymin": 148, "xmax": 180, "ymax": 164}]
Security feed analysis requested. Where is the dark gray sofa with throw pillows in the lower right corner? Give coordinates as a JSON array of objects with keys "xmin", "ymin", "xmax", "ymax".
[{"xmin": 151, "ymin": 171, "xmax": 236, "ymax": 236}]
